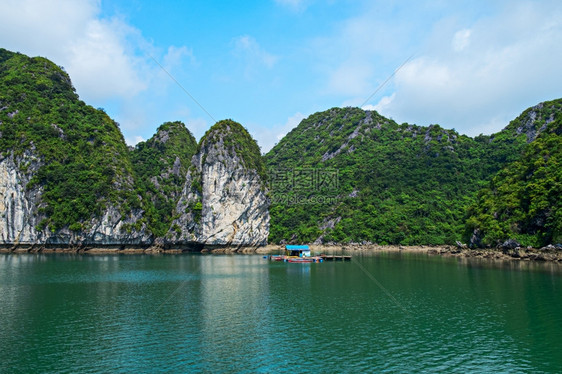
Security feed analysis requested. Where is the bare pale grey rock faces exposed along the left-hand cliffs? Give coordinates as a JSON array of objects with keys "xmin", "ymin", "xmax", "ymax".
[{"xmin": 0, "ymin": 122, "xmax": 269, "ymax": 248}]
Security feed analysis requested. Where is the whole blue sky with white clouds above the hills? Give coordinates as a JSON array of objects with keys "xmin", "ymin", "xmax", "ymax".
[{"xmin": 0, "ymin": 0, "xmax": 562, "ymax": 152}]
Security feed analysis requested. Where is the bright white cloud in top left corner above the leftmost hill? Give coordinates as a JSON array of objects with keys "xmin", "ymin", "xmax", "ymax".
[{"xmin": 0, "ymin": 0, "xmax": 150, "ymax": 101}]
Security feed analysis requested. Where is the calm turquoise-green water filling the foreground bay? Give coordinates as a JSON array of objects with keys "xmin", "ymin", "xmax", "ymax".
[{"xmin": 0, "ymin": 253, "xmax": 562, "ymax": 373}]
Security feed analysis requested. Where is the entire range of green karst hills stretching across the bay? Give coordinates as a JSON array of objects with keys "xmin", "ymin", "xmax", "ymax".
[{"xmin": 0, "ymin": 49, "xmax": 562, "ymax": 258}]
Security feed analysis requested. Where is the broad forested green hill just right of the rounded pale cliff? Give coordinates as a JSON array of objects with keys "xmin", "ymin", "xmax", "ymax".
[{"xmin": 265, "ymin": 108, "xmax": 536, "ymax": 245}]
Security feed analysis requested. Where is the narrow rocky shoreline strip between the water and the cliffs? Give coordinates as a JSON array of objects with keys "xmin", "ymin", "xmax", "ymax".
[{"xmin": 0, "ymin": 244, "xmax": 562, "ymax": 263}]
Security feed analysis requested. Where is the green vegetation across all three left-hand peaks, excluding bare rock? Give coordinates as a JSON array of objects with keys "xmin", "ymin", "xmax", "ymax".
[{"xmin": 0, "ymin": 49, "xmax": 265, "ymax": 237}]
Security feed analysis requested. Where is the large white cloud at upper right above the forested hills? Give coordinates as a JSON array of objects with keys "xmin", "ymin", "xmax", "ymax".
[{"xmin": 346, "ymin": 2, "xmax": 562, "ymax": 135}]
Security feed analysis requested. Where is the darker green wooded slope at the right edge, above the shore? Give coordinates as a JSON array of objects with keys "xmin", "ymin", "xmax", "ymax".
[{"xmin": 465, "ymin": 99, "xmax": 562, "ymax": 246}]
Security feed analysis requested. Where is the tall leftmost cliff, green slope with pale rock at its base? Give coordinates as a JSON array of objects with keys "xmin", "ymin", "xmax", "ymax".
[{"xmin": 0, "ymin": 49, "xmax": 147, "ymax": 247}]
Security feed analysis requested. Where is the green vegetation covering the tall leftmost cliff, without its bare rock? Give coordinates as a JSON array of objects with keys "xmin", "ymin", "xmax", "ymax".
[{"xmin": 0, "ymin": 49, "xmax": 140, "ymax": 231}]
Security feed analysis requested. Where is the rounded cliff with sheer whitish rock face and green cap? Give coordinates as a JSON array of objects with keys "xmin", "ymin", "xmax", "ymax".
[{"xmin": 167, "ymin": 120, "xmax": 269, "ymax": 246}]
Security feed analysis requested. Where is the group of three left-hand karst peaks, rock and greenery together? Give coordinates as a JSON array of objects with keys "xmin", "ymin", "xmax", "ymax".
[{"xmin": 0, "ymin": 48, "xmax": 269, "ymax": 248}]
